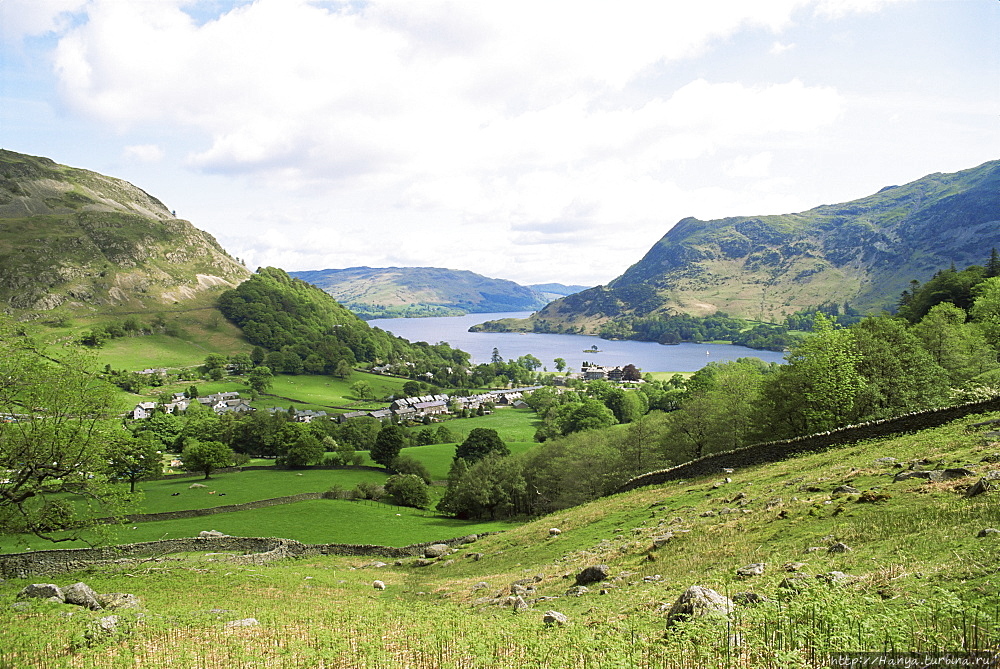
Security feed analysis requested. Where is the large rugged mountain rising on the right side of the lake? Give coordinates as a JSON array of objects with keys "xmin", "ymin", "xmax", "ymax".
[{"xmin": 505, "ymin": 161, "xmax": 1000, "ymax": 333}]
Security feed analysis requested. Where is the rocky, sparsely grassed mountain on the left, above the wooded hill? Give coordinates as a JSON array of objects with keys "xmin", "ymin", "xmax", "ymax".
[{"xmin": 0, "ymin": 150, "xmax": 250, "ymax": 311}]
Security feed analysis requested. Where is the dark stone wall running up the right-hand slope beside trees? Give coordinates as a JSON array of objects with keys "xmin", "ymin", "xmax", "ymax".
[{"xmin": 616, "ymin": 398, "xmax": 1000, "ymax": 492}]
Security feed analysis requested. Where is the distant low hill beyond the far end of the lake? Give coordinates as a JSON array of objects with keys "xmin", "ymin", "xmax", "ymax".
[{"xmin": 289, "ymin": 267, "xmax": 548, "ymax": 318}]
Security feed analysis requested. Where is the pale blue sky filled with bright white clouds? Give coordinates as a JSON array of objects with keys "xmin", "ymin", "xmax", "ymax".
[{"xmin": 0, "ymin": 0, "xmax": 1000, "ymax": 285}]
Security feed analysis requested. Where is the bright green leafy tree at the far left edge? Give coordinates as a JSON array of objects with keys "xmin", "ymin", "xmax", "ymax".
[{"xmin": 0, "ymin": 317, "xmax": 126, "ymax": 541}]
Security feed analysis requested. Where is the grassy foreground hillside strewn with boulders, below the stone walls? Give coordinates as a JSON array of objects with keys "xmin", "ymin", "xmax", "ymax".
[{"xmin": 0, "ymin": 414, "xmax": 1000, "ymax": 669}]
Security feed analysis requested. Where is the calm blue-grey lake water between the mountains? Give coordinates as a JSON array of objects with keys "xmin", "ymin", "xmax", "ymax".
[{"xmin": 368, "ymin": 311, "xmax": 784, "ymax": 372}]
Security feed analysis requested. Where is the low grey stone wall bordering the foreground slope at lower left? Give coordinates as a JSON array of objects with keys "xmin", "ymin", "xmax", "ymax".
[{"xmin": 0, "ymin": 535, "xmax": 483, "ymax": 578}]
